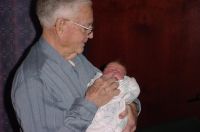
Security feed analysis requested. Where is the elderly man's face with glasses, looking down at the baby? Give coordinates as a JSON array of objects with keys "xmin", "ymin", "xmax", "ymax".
[{"xmin": 62, "ymin": 4, "xmax": 93, "ymax": 54}]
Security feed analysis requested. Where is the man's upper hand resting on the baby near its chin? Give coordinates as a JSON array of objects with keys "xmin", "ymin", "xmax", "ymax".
[{"xmin": 86, "ymin": 75, "xmax": 120, "ymax": 107}]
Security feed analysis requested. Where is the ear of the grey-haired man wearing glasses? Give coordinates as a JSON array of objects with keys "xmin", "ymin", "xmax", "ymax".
[{"xmin": 55, "ymin": 18, "xmax": 65, "ymax": 36}]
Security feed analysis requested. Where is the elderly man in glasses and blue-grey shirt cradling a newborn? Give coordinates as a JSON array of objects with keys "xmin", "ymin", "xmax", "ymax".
[{"xmin": 11, "ymin": 0, "xmax": 140, "ymax": 132}]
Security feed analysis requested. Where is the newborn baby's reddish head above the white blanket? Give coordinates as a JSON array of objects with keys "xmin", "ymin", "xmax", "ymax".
[{"xmin": 103, "ymin": 62, "xmax": 126, "ymax": 80}]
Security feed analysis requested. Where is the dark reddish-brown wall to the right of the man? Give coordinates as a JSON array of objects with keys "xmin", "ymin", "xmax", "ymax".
[{"xmin": 87, "ymin": 0, "xmax": 200, "ymax": 126}]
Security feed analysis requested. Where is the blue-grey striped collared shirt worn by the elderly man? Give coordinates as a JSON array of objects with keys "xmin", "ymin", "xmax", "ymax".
[{"xmin": 11, "ymin": 38, "xmax": 98, "ymax": 132}]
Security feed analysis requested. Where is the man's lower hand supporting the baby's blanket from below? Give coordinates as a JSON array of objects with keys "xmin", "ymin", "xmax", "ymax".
[{"xmin": 119, "ymin": 103, "xmax": 138, "ymax": 132}]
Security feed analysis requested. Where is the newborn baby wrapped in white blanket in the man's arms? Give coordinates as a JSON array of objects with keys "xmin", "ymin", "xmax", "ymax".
[{"xmin": 86, "ymin": 62, "xmax": 140, "ymax": 132}]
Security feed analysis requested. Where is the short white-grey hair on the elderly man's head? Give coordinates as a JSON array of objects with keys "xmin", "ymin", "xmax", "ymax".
[{"xmin": 36, "ymin": 0, "xmax": 92, "ymax": 27}]
